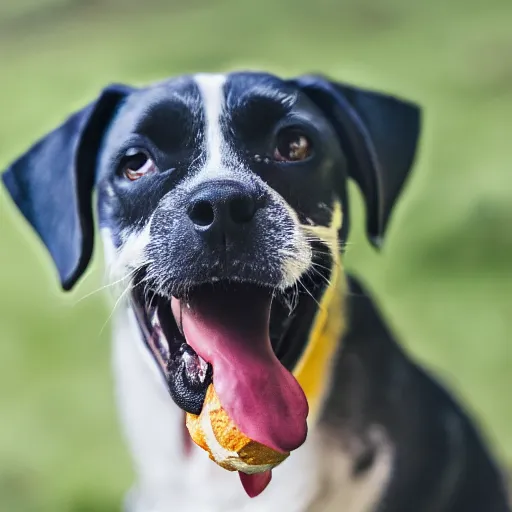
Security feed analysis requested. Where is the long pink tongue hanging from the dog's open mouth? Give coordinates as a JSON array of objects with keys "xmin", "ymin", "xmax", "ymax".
[{"xmin": 172, "ymin": 287, "xmax": 308, "ymax": 454}]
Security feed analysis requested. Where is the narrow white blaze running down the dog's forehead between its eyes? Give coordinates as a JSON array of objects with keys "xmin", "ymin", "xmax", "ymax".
[{"xmin": 194, "ymin": 74, "xmax": 226, "ymax": 172}]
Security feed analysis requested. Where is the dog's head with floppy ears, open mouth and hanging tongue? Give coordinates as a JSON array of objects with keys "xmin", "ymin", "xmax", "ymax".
[{"xmin": 3, "ymin": 73, "xmax": 419, "ymax": 456}]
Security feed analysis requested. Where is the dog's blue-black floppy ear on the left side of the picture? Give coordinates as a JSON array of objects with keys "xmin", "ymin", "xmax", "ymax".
[{"xmin": 2, "ymin": 85, "xmax": 133, "ymax": 290}]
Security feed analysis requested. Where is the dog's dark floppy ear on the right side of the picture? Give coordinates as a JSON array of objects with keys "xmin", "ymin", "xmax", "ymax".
[{"xmin": 293, "ymin": 76, "xmax": 420, "ymax": 247}]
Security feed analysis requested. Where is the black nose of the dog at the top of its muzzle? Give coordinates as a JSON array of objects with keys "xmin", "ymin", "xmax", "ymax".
[{"xmin": 187, "ymin": 180, "xmax": 261, "ymax": 234}]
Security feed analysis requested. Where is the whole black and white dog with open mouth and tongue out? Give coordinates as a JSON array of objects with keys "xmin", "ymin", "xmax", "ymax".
[{"xmin": 3, "ymin": 73, "xmax": 509, "ymax": 512}]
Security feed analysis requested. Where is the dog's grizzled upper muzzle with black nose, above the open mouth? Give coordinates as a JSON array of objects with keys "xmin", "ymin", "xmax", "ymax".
[{"xmin": 147, "ymin": 179, "xmax": 311, "ymax": 296}]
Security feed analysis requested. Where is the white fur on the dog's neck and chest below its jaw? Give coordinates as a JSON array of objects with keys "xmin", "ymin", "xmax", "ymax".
[{"xmin": 113, "ymin": 304, "xmax": 319, "ymax": 512}]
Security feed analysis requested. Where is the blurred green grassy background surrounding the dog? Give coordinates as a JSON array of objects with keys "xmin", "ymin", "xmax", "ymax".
[{"xmin": 0, "ymin": 0, "xmax": 512, "ymax": 512}]
